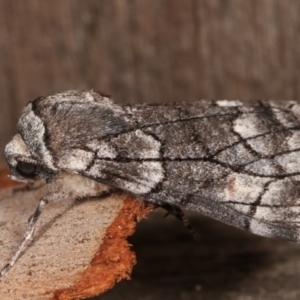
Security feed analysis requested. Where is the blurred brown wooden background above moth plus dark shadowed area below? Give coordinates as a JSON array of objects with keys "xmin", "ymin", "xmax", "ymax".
[{"xmin": 0, "ymin": 0, "xmax": 300, "ymax": 300}]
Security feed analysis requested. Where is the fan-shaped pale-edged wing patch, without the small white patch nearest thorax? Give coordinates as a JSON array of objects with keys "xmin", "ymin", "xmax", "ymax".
[{"xmin": 88, "ymin": 129, "xmax": 164, "ymax": 194}]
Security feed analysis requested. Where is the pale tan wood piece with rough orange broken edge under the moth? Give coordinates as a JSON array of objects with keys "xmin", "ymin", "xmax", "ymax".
[{"xmin": 0, "ymin": 169, "xmax": 151, "ymax": 300}]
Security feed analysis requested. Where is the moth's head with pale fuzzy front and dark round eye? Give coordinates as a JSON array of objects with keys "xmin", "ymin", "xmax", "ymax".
[{"xmin": 5, "ymin": 134, "xmax": 53, "ymax": 182}]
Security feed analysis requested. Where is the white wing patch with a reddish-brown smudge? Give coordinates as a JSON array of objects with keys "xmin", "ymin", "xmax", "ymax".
[{"xmin": 223, "ymin": 173, "xmax": 270, "ymax": 204}]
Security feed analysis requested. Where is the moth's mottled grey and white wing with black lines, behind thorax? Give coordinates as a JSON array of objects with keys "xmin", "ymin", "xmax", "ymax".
[{"xmin": 84, "ymin": 101, "xmax": 300, "ymax": 241}]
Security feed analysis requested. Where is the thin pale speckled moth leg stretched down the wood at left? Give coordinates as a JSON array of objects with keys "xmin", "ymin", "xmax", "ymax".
[{"xmin": 0, "ymin": 194, "xmax": 57, "ymax": 278}]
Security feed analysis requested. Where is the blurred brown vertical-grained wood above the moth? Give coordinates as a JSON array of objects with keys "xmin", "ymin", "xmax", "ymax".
[{"xmin": 0, "ymin": 0, "xmax": 300, "ymax": 160}]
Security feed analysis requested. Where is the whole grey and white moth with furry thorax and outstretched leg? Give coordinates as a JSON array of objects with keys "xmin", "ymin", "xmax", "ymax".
[{"xmin": 0, "ymin": 91, "xmax": 300, "ymax": 276}]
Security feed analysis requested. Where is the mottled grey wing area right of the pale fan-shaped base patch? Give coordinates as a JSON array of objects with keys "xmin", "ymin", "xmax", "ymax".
[{"xmin": 145, "ymin": 101, "xmax": 300, "ymax": 241}]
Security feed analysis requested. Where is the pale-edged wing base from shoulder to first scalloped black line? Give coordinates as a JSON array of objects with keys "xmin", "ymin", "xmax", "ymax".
[{"xmin": 55, "ymin": 129, "xmax": 164, "ymax": 195}]
